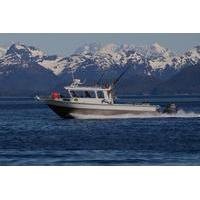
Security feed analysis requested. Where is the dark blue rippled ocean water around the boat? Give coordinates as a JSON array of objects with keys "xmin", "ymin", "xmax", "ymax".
[{"xmin": 0, "ymin": 96, "xmax": 200, "ymax": 166}]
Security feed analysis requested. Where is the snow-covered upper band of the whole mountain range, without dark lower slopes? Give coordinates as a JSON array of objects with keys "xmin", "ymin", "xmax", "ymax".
[{"xmin": 0, "ymin": 43, "xmax": 200, "ymax": 76}]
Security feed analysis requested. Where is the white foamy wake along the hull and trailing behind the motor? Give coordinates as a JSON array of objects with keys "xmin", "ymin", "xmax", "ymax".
[{"xmin": 71, "ymin": 110, "xmax": 200, "ymax": 119}]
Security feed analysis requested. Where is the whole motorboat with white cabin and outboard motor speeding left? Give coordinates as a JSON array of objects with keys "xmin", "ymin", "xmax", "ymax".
[{"xmin": 36, "ymin": 78, "xmax": 177, "ymax": 118}]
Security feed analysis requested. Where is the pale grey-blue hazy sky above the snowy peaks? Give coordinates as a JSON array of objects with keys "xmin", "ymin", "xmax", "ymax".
[{"xmin": 0, "ymin": 33, "xmax": 200, "ymax": 55}]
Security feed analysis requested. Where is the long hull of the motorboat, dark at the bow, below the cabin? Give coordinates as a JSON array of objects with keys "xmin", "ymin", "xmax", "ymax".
[{"xmin": 43, "ymin": 100, "xmax": 160, "ymax": 118}]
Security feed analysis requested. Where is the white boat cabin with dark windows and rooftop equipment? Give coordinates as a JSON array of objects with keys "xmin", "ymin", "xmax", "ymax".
[{"xmin": 64, "ymin": 79, "xmax": 113, "ymax": 104}]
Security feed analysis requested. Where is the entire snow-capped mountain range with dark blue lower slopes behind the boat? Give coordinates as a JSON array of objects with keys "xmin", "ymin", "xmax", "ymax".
[{"xmin": 0, "ymin": 43, "xmax": 200, "ymax": 93}]
